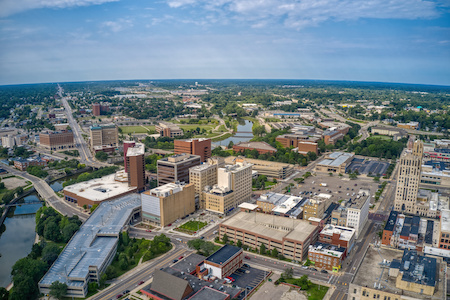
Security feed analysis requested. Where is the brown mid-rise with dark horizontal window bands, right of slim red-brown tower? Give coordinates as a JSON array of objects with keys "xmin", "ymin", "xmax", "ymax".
[{"xmin": 157, "ymin": 153, "xmax": 201, "ymax": 186}]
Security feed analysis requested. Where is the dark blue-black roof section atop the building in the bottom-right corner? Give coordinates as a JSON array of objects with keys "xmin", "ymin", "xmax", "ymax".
[{"xmin": 400, "ymin": 250, "xmax": 437, "ymax": 286}]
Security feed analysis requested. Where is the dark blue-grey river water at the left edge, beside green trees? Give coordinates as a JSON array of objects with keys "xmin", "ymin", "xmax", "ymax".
[{"xmin": 0, "ymin": 194, "xmax": 42, "ymax": 287}]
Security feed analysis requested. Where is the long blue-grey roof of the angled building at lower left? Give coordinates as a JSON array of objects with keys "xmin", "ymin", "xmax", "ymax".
[{"xmin": 39, "ymin": 194, "xmax": 141, "ymax": 287}]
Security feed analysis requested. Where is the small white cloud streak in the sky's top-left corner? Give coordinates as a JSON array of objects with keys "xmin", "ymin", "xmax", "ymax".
[{"xmin": 0, "ymin": 0, "xmax": 119, "ymax": 17}]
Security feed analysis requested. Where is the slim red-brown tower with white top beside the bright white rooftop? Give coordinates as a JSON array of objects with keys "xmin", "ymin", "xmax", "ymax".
[{"xmin": 125, "ymin": 143, "xmax": 145, "ymax": 191}]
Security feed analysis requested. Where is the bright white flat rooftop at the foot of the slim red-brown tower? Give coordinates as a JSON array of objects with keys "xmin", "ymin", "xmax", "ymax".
[{"xmin": 64, "ymin": 174, "xmax": 136, "ymax": 202}]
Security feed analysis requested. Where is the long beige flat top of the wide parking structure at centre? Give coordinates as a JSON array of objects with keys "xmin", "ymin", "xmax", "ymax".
[{"xmin": 222, "ymin": 212, "xmax": 317, "ymax": 242}]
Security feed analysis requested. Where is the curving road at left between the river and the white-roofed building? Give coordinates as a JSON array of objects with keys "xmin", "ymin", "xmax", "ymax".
[{"xmin": 2, "ymin": 165, "xmax": 89, "ymax": 221}]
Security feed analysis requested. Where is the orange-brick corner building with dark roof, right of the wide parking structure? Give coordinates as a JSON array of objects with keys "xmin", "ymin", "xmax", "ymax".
[{"xmin": 308, "ymin": 242, "xmax": 346, "ymax": 272}]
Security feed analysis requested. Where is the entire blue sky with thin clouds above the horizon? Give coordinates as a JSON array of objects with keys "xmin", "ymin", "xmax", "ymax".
[{"xmin": 0, "ymin": 0, "xmax": 450, "ymax": 85}]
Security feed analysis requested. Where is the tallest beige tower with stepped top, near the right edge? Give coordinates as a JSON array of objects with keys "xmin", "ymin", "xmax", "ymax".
[{"xmin": 394, "ymin": 138, "xmax": 423, "ymax": 214}]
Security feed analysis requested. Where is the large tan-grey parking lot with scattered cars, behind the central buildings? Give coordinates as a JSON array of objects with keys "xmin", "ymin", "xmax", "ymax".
[{"xmin": 290, "ymin": 173, "xmax": 379, "ymax": 202}]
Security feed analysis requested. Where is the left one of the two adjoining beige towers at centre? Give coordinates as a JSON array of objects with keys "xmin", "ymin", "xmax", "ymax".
[{"xmin": 189, "ymin": 161, "xmax": 217, "ymax": 209}]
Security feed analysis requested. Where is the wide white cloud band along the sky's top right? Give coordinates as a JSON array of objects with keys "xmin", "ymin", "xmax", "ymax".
[{"xmin": 167, "ymin": 0, "xmax": 441, "ymax": 29}]
